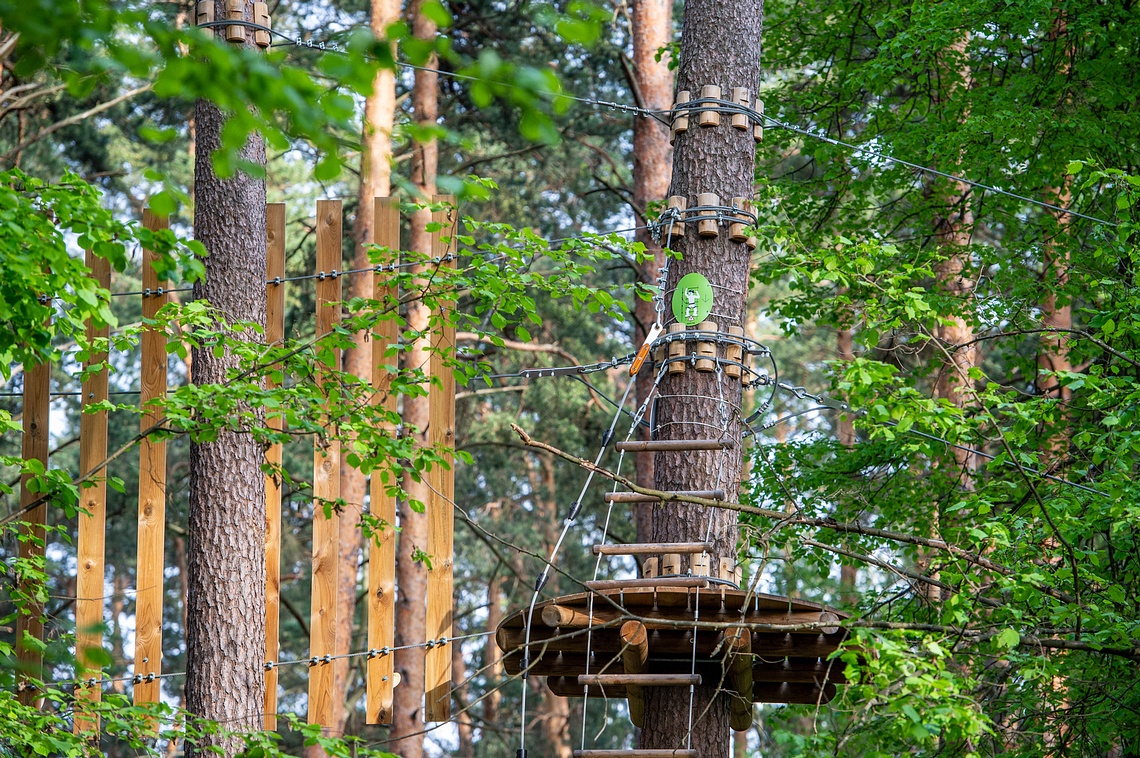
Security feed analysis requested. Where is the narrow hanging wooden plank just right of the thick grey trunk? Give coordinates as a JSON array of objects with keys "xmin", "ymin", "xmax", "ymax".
[{"xmin": 264, "ymin": 203, "xmax": 285, "ymax": 731}]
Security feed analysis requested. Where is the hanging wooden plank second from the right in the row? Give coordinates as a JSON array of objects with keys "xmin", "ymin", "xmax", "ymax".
[{"xmin": 365, "ymin": 197, "xmax": 400, "ymax": 724}]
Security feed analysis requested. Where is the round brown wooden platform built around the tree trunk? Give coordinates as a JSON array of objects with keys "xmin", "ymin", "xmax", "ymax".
[{"xmin": 496, "ymin": 580, "xmax": 847, "ymax": 703}]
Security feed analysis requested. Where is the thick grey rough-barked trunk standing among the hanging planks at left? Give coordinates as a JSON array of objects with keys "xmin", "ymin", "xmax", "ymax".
[{"xmin": 186, "ymin": 1, "xmax": 266, "ymax": 756}]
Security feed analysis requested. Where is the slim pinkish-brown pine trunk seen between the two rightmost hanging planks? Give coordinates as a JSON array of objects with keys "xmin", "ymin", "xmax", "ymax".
[{"xmin": 391, "ymin": 0, "xmax": 439, "ymax": 758}]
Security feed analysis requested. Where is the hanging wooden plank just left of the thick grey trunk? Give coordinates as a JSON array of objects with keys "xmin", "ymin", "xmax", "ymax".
[{"xmin": 135, "ymin": 209, "xmax": 170, "ymax": 704}]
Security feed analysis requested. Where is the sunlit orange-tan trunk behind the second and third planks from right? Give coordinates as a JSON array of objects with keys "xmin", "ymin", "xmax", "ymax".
[{"xmin": 318, "ymin": 0, "xmax": 400, "ymax": 749}]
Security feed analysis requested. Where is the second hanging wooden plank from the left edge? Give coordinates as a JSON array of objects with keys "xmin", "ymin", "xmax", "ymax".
[{"xmin": 75, "ymin": 251, "xmax": 111, "ymax": 734}]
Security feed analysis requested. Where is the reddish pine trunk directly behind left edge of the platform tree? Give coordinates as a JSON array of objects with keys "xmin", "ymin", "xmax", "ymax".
[{"xmin": 630, "ymin": 0, "xmax": 673, "ymax": 541}]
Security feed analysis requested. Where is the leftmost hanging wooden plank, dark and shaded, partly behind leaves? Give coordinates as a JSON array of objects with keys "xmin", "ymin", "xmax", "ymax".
[{"xmin": 16, "ymin": 341, "xmax": 51, "ymax": 704}]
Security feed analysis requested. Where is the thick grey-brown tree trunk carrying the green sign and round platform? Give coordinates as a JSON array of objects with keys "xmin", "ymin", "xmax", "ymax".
[{"xmin": 641, "ymin": 0, "xmax": 764, "ymax": 758}]
